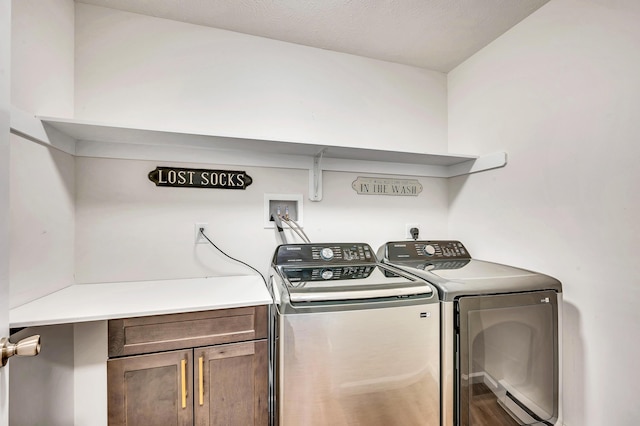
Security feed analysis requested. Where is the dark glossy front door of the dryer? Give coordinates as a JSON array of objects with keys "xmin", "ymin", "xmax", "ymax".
[{"xmin": 456, "ymin": 291, "xmax": 559, "ymax": 426}]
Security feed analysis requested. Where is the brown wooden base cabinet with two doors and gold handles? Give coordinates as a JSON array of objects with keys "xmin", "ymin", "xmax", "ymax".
[{"xmin": 107, "ymin": 306, "xmax": 268, "ymax": 426}]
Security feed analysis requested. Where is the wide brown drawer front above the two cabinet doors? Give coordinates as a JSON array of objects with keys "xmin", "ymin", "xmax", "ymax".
[{"xmin": 109, "ymin": 306, "xmax": 267, "ymax": 358}]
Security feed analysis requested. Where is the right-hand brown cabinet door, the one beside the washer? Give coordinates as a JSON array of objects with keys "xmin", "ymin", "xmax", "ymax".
[{"xmin": 194, "ymin": 340, "xmax": 268, "ymax": 426}]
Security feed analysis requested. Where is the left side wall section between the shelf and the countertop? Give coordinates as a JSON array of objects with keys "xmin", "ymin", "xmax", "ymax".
[{"xmin": 9, "ymin": 135, "xmax": 75, "ymax": 307}]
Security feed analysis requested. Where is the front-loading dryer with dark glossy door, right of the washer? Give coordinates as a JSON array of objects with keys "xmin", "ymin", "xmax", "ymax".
[{"xmin": 378, "ymin": 241, "xmax": 562, "ymax": 426}]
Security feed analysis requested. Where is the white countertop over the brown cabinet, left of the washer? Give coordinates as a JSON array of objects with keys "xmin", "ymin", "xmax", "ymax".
[{"xmin": 9, "ymin": 275, "xmax": 271, "ymax": 328}]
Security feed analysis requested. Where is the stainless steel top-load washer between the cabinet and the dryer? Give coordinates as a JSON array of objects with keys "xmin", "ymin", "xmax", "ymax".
[{"xmin": 269, "ymin": 243, "xmax": 441, "ymax": 426}]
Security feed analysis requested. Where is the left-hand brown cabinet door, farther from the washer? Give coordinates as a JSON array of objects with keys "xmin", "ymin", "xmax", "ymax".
[{"xmin": 107, "ymin": 350, "xmax": 193, "ymax": 426}]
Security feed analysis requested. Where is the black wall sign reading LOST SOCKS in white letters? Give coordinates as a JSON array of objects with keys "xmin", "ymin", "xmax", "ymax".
[{"xmin": 149, "ymin": 167, "xmax": 253, "ymax": 189}]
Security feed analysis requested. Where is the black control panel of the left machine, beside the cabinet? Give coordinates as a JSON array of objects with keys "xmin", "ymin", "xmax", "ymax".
[{"xmin": 273, "ymin": 243, "xmax": 377, "ymax": 265}]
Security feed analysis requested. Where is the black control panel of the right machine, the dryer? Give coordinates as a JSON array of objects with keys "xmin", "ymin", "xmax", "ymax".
[{"xmin": 384, "ymin": 240, "xmax": 471, "ymax": 261}]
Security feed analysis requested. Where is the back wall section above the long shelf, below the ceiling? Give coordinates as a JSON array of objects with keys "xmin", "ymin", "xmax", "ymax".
[{"xmin": 75, "ymin": 4, "xmax": 447, "ymax": 152}]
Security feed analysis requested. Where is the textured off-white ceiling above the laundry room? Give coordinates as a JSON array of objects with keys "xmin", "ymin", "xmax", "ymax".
[{"xmin": 77, "ymin": 0, "xmax": 549, "ymax": 72}]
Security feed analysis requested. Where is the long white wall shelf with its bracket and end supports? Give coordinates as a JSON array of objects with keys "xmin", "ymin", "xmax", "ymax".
[{"xmin": 11, "ymin": 109, "xmax": 506, "ymax": 201}]
